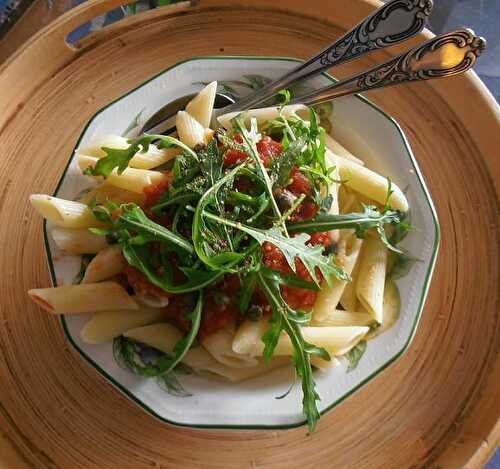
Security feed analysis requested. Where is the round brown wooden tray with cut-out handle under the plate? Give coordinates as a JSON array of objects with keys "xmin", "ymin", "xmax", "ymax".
[{"xmin": 0, "ymin": 0, "xmax": 500, "ymax": 468}]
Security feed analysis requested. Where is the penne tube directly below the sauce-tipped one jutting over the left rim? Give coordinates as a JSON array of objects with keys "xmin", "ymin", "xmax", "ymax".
[{"xmin": 80, "ymin": 306, "xmax": 165, "ymax": 344}]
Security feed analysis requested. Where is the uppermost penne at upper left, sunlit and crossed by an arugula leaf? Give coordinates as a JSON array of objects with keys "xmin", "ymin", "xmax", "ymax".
[{"xmin": 77, "ymin": 135, "xmax": 181, "ymax": 169}]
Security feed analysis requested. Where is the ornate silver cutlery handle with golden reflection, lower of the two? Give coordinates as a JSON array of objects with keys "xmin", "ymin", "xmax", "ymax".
[{"xmin": 290, "ymin": 29, "xmax": 486, "ymax": 105}]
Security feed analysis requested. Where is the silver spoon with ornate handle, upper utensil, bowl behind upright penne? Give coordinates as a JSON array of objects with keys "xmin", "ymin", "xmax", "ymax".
[{"xmin": 141, "ymin": 0, "xmax": 433, "ymax": 133}]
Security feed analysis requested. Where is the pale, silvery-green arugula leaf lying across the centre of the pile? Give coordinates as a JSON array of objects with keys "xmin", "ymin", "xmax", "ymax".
[{"xmin": 199, "ymin": 212, "xmax": 350, "ymax": 285}]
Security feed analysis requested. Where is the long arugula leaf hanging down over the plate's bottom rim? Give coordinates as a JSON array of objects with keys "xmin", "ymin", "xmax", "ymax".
[{"xmin": 257, "ymin": 272, "xmax": 330, "ymax": 433}]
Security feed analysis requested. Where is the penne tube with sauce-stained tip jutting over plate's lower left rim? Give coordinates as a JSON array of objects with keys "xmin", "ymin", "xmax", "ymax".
[{"xmin": 28, "ymin": 282, "xmax": 138, "ymax": 314}]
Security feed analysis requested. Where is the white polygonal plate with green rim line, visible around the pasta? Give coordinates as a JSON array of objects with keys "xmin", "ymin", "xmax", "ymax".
[{"xmin": 45, "ymin": 57, "xmax": 439, "ymax": 429}]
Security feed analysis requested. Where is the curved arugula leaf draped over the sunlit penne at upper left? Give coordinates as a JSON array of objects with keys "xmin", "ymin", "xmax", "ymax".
[{"xmin": 83, "ymin": 135, "xmax": 198, "ymax": 178}]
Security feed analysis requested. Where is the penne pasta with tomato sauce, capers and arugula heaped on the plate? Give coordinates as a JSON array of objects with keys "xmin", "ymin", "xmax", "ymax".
[{"xmin": 29, "ymin": 82, "xmax": 411, "ymax": 431}]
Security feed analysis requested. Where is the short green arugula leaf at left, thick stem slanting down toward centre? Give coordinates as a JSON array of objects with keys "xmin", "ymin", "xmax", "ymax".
[{"xmin": 115, "ymin": 204, "xmax": 194, "ymax": 254}]
